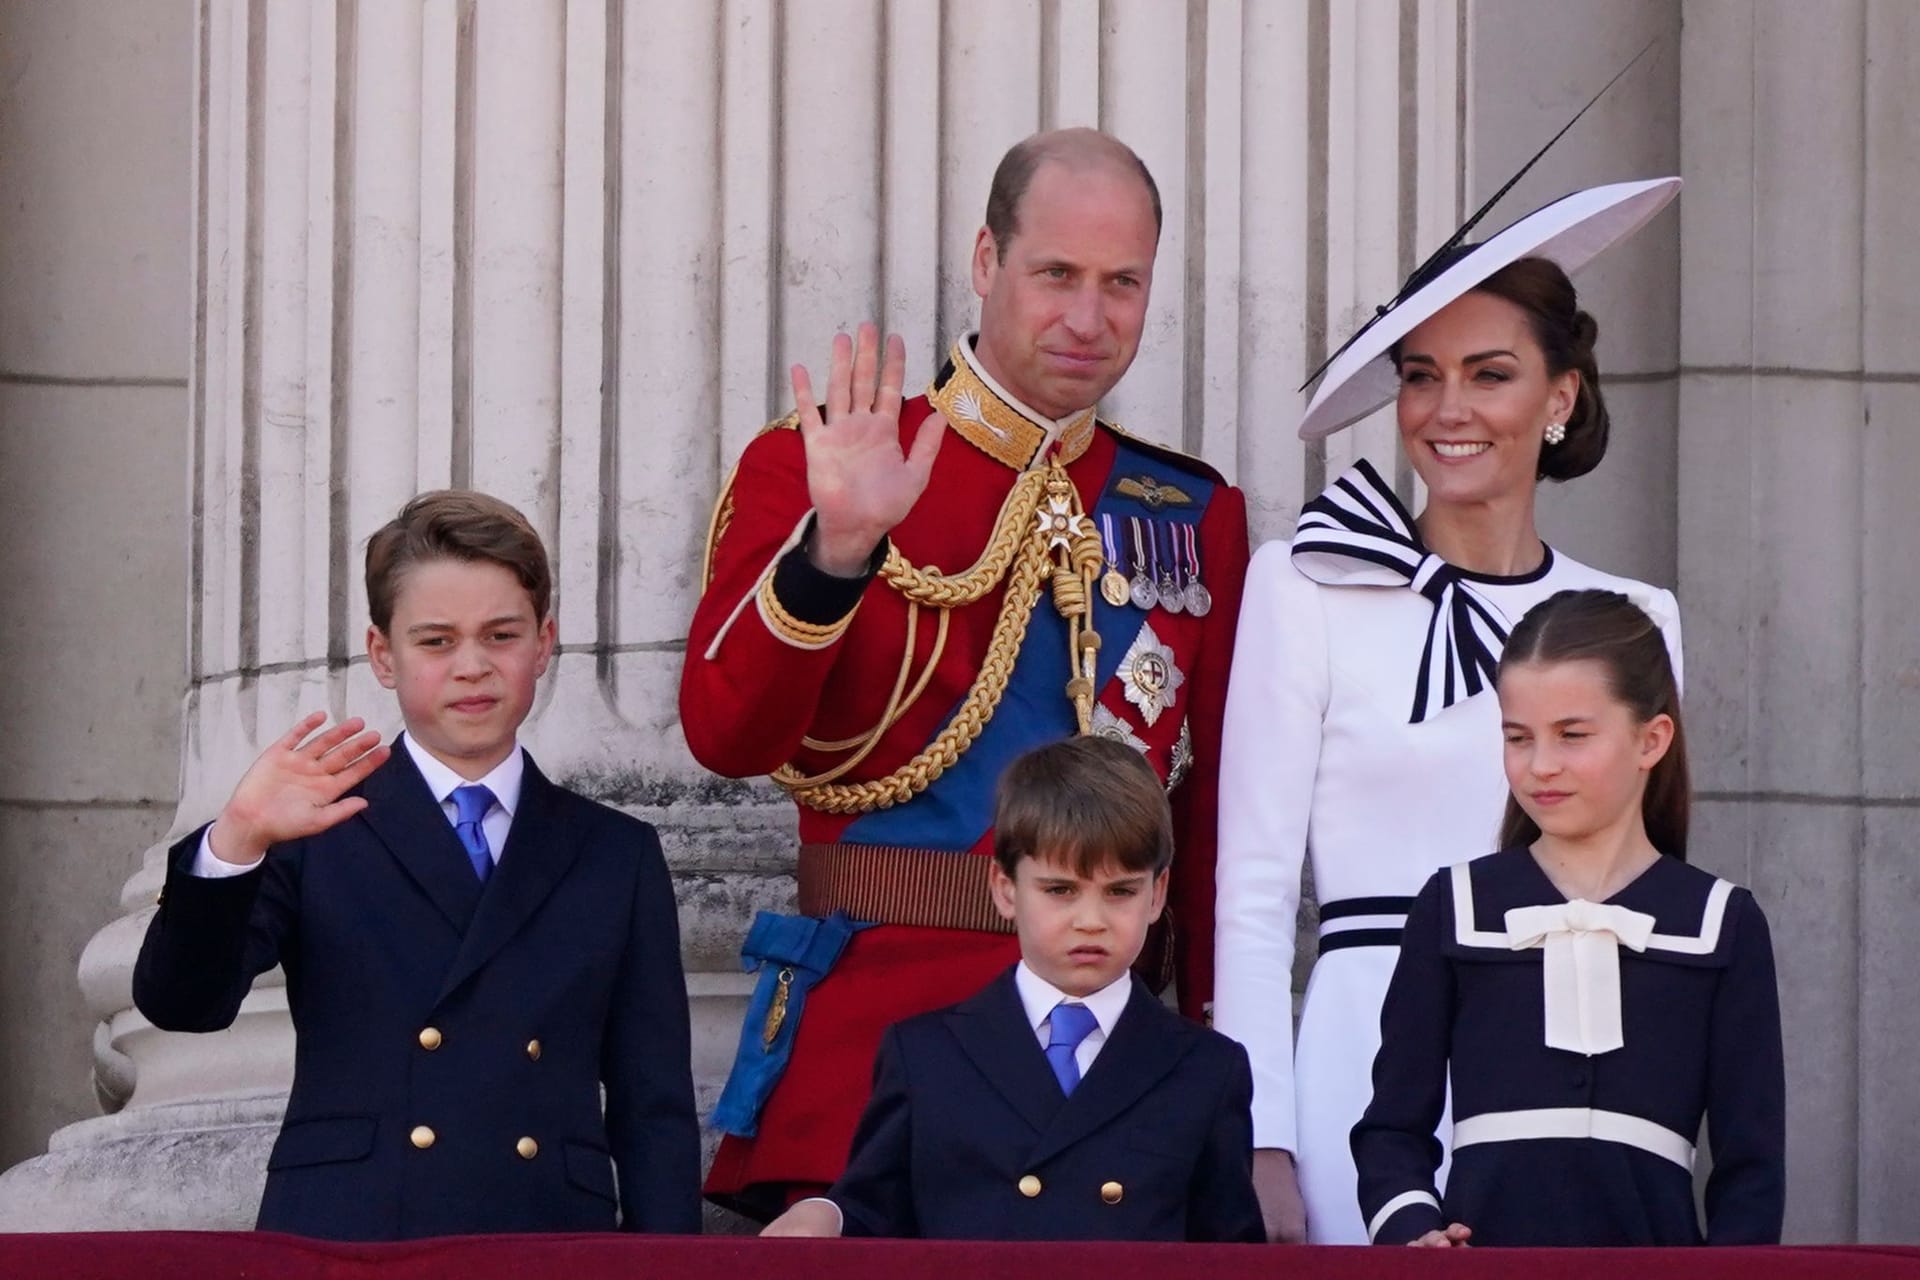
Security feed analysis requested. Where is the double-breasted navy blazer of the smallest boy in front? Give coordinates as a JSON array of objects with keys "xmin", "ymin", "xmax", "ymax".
[{"xmin": 828, "ymin": 969, "xmax": 1263, "ymax": 1242}]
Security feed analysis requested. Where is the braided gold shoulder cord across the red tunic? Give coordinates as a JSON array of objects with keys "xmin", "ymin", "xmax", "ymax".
[{"xmin": 707, "ymin": 410, "xmax": 1104, "ymax": 814}]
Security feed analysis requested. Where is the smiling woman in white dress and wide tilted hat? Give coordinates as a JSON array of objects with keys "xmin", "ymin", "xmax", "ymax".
[{"xmin": 1213, "ymin": 178, "xmax": 1680, "ymax": 1244}]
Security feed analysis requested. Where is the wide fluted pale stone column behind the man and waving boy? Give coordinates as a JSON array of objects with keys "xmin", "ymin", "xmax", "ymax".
[{"xmin": 0, "ymin": 0, "xmax": 1463, "ymax": 1230}]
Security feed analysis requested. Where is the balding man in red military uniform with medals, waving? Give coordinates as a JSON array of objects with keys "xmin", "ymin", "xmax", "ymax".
[{"xmin": 680, "ymin": 129, "xmax": 1248, "ymax": 1217}]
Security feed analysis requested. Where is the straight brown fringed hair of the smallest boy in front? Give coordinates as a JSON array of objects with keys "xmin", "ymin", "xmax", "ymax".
[{"xmin": 993, "ymin": 737, "xmax": 1173, "ymax": 877}]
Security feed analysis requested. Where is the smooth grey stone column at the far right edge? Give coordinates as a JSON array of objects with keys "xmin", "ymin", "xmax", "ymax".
[{"xmin": 1680, "ymin": 0, "xmax": 1920, "ymax": 1240}]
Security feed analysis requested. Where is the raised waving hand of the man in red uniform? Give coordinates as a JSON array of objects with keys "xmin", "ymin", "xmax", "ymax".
[{"xmin": 791, "ymin": 324, "xmax": 947, "ymax": 578}]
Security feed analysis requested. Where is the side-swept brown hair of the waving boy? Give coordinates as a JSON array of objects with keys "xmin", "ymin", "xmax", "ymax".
[{"xmin": 367, "ymin": 489, "xmax": 553, "ymax": 631}]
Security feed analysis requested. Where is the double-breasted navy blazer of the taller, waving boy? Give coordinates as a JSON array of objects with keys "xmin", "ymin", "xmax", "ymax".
[{"xmin": 132, "ymin": 750, "xmax": 701, "ymax": 1240}]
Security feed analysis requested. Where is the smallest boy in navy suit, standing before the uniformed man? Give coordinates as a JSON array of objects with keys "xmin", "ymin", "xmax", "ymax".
[{"xmin": 762, "ymin": 737, "xmax": 1265, "ymax": 1244}]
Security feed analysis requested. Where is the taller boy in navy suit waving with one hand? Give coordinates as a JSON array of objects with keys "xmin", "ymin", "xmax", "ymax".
[{"xmin": 132, "ymin": 491, "xmax": 701, "ymax": 1240}]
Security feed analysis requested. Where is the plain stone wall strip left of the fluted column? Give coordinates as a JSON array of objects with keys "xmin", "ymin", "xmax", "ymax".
[{"xmin": 0, "ymin": 0, "xmax": 194, "ymax": 1167}]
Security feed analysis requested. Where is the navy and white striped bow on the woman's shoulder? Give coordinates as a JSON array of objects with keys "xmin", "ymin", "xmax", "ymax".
[{"xmin": 1294, "ymin": 459, "xmax": 1507, "ymax": 723}]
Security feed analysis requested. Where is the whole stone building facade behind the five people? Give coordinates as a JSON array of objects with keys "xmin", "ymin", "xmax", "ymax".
[{"xmin": 0, "ymin": 0, "xmax": 1920, "ymax": 1240}]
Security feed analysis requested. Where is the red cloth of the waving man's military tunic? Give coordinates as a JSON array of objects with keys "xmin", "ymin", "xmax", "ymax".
[{"xmin": 680, "ymin": 355, "xmax": 1248, "ymax": 1207}]
